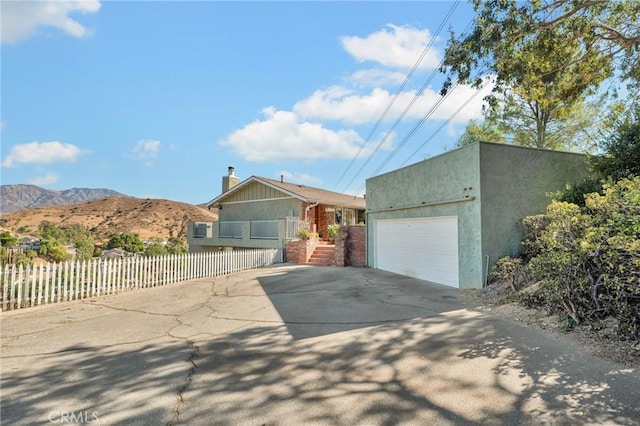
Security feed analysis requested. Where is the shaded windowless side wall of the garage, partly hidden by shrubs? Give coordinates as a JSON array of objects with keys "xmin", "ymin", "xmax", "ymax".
[{"xmin": 478, "ymin": 143, "xmax": 587, "ymax": 266}]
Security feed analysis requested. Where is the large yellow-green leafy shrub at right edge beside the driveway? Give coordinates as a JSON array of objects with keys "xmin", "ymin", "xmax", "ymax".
[{"xmin": 529, "ymin": 177, "xmax": 640, "ymax": 339}]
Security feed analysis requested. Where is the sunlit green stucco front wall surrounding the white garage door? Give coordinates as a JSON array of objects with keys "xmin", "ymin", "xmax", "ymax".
[{"xmin": 366, "ymin": 145, "xmax": 483, "ymax": 288}]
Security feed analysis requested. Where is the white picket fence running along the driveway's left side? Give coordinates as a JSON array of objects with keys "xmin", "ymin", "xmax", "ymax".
[{"xmin": 0, "ymin": 249, "xmax": 283, "ymax": 311}]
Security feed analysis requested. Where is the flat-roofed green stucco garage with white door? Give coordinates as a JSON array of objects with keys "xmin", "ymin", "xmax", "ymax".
[{"xmin": 366, "ymin": 142, "xmax": 588, "ymax": 288}]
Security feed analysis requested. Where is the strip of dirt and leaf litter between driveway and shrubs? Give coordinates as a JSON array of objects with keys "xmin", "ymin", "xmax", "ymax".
[{"xmin": 462, "ymin": 285, "xmax": 640, "ymax": 368}]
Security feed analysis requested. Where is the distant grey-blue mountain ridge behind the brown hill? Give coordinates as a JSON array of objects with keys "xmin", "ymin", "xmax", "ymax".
[{"xmin": 0, "ymin": 185, "xmax": 125, "ymax": 213}]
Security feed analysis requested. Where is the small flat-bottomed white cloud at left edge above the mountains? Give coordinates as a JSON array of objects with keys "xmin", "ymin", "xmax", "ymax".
[{"xmin": 2, "ymin": 141, "xmax": 82, "ymax": 167}]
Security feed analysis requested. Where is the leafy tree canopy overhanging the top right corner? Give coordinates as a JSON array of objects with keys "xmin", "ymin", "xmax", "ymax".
[{"xmin": 444, "ymin": 0, "xmax": 640, "ymax": 90}]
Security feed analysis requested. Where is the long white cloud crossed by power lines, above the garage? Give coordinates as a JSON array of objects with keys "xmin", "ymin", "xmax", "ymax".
[{"xmin": 293, "ymin": 82, "xmax": 491, "ymax": 124}]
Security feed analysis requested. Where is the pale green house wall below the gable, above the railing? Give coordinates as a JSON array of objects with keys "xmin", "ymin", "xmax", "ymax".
[{"xmin": 218, "ymin": 198, "xmax": 301, "ymax": 222}]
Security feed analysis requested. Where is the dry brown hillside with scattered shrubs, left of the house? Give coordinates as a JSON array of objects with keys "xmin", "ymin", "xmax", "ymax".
[{"xmin": 0, "ymin": 196, "xmax": 218, "ymax": 239}]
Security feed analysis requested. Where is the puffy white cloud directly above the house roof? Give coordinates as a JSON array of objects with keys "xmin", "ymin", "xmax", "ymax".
[{"xmin": 219, "ymin": 108, "xmax": 390, "ymax": 162}]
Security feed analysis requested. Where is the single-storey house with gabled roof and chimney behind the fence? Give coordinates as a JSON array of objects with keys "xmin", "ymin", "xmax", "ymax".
[{"xmin": 187, "ymin": 167, "xmax": 365, "ymax": 252}]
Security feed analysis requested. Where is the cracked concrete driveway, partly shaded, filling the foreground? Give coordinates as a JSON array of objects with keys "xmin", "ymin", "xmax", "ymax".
[{"xmin": 0, "ymin": 265, "xmax": 640, "ymax": 425}]
